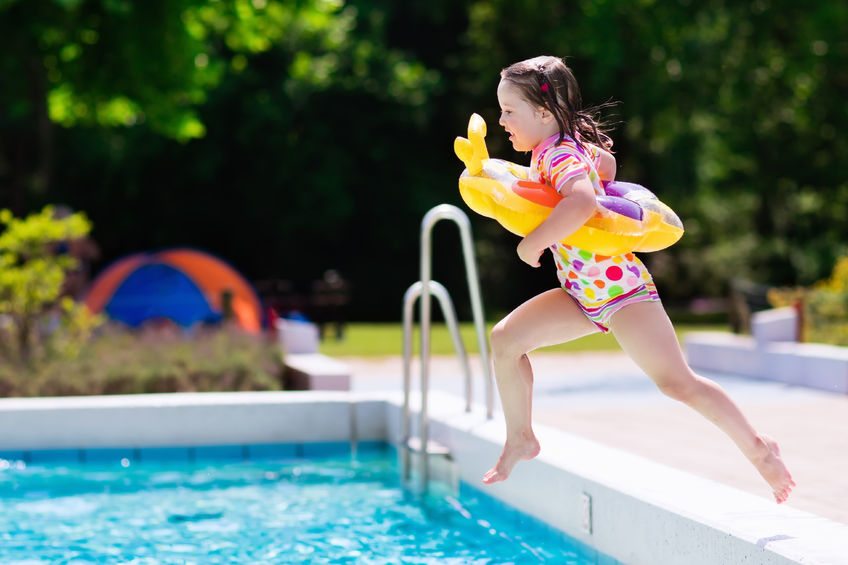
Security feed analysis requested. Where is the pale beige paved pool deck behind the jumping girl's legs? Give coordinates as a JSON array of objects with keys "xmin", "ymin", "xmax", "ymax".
[{"xmin": 341, "ymin": 352, "xmax": 848, "ymax": 524}]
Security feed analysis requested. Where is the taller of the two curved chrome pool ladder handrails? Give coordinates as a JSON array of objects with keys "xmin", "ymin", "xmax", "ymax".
[{"xmin": 404, "ymin": 204, "xmax": 494, "ymax": 489}]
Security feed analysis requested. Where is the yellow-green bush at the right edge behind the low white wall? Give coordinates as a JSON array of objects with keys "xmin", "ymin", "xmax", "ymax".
[{"xmin": 769, "ymin": 257, "xmax": 848, "ymax": 346}]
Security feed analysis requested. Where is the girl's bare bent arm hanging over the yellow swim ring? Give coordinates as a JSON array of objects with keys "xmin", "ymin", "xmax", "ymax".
[{"xmin": 517, "ymin": 175, "xmax": 595, "ymax": 267}]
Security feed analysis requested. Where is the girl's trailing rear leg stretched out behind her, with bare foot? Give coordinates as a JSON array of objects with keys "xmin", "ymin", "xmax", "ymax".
[{"xmin": 610, "ymin": 302, "xmax": 795, "ymax": 503}]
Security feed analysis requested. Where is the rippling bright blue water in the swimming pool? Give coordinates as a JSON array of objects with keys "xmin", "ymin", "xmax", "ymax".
[{"xmin": 0, "ymin": 450, "xmax": 614, "ymax": 565}]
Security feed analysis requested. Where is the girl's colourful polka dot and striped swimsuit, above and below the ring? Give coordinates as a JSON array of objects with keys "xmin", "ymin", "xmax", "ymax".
[{"xmin": 530, "ymin": 135, "xmax": 659, "ymax": 333}]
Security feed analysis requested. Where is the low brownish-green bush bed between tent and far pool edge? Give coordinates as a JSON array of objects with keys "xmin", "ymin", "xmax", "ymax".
[{"xmin": 0, "ymin": 326, "xmax": 283, "ymax": 396}]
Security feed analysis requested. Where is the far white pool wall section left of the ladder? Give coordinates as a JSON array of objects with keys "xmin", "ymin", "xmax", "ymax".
[{"xmin": 0, "ymin": 392, "xmax": 388, "ymax": 451}]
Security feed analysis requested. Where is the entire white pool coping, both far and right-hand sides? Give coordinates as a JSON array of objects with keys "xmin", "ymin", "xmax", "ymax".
[{"xmin": 0, "ymin": 391, "xmax": 848, "ymax": 565}]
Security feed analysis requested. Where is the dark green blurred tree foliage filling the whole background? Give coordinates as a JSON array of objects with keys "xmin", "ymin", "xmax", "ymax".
[{"xmin": 0, "ymin": 0, "xmax": 848, "ymax": 319}]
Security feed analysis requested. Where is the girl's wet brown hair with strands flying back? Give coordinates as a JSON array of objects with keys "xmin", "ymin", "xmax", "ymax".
[{"xmin": 501, "ymin": 55, "xmax": 613, "ymax": 150}]
